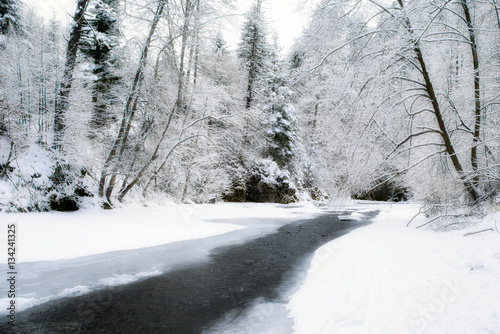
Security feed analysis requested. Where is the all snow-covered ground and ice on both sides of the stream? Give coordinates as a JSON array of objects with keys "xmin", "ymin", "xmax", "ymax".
[{"xmin": 0, "ymin": 203, "xmax": 500, "ymax": 334}]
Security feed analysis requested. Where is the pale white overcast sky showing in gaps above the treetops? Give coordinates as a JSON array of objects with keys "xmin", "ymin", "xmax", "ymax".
[{"xmin": 23, "ymin": 0, "xmax": 307, "ymax": 52}]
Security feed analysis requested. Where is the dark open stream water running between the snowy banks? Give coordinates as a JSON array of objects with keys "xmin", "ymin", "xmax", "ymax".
[{"xmin": 0, "ymin": 214, "xmax": 367, "ymax": 334}]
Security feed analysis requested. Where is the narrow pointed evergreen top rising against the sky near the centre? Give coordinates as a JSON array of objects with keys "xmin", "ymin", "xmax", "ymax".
[{"xmin": 238, "ymin": 0, "xmax": 270, "ymax": 109}]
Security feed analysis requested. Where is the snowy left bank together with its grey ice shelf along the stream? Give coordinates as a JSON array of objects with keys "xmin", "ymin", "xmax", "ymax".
[{"xmin": 0, "ymin": 203, "xmax": 320, "ymax": 314}]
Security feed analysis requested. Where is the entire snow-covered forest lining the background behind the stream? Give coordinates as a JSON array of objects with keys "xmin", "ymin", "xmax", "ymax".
[{"xmin": 0, "ymin": 0, "xmax": 500, "ymax": 213}]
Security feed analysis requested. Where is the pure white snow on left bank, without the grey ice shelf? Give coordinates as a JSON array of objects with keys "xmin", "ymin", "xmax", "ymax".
[{"xmin": 0, "ymin": 203, "xmax": 317, "ymax": 263}]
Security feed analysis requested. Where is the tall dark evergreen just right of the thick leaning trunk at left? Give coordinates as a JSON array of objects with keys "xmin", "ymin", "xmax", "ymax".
[{"xmin": 80, "ymin": 0, "xmax": 121, "ymax": 128}]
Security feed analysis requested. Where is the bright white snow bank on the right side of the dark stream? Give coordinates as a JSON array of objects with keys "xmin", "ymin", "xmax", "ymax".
[{"xmin": 287, "ymin": 204, "xmax": 500, "ymax": 334}]
